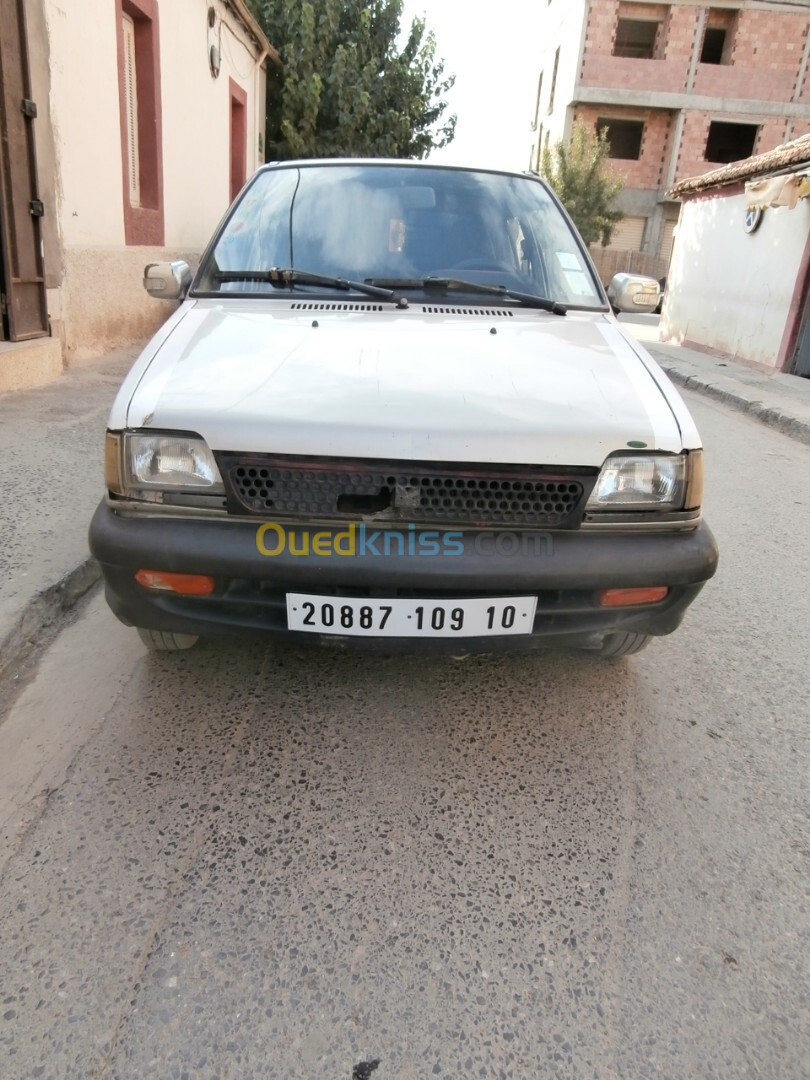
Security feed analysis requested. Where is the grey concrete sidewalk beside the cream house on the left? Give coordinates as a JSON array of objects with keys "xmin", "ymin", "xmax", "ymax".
[{"xmin": 0, "ymin": 346, "xmax": 140, "ymax": 675}]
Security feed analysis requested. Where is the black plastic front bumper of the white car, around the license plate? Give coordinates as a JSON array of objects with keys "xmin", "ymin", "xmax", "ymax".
[{"xmin": 90, "ymin": 501, "xmax": 717, "ymax": 652}]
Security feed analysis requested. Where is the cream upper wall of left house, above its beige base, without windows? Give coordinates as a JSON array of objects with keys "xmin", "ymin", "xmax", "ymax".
[{"xmin": 45, "ymin": 0, "xmax": 265, "ymax": 249}]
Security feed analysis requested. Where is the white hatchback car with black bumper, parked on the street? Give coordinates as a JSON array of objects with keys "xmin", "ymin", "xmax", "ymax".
[{"xmin": 90, "ymin": 160, "xmax": 717, "ymax": 656}]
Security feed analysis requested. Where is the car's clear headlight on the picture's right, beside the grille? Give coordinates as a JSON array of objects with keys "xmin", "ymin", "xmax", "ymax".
[{"xmin": 586, "ymin": 454, "xmax": 689, "ymax": 511}]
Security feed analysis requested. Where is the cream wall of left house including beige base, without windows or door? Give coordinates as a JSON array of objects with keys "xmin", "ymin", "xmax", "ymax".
[{"xmin": 42, "ymin": 0, "xmax": 266, "ymax": 361}]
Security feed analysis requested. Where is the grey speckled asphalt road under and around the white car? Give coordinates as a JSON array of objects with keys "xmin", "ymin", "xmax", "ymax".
[{"xmin": 0, "ymin": 399, "xmax": 810, "ymax": 1080}]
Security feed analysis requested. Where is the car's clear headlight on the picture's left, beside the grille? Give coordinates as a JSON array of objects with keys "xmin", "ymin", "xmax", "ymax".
[{"xmin": 123, "ymin": 434, "xmax": 225, "ymax": 494}]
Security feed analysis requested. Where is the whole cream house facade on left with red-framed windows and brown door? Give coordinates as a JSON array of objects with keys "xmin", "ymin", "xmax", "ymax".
[{"xmin": 0, "ymin": 0, "xmax": 279, "ymax": 390}]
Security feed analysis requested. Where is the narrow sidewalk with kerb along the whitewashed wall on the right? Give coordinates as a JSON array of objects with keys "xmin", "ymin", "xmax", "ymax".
[{"xmin": 620, "ymin": 316, "xmax": 810, "ymax": 444}]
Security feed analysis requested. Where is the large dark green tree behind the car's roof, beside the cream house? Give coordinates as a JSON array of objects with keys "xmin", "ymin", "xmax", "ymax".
[{"xmin": 249, "ymin": 0, "xmax": 456, "ymax": 161}]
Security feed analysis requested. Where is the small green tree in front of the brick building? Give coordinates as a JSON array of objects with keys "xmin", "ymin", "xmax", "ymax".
[{"xmin": 540, "ymin": 120, "xmax": 624, "ymax": 245}]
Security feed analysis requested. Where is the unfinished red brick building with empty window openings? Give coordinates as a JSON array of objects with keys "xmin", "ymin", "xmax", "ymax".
[{"xmin": 530, "ymin": 0, "xmax": 810, "ymax": 269}]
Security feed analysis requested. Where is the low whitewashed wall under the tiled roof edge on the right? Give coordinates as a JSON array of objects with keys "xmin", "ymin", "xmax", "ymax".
[{"xmin": 661, "ymin": 193, "xmax": 810, "ymax": 366}]
